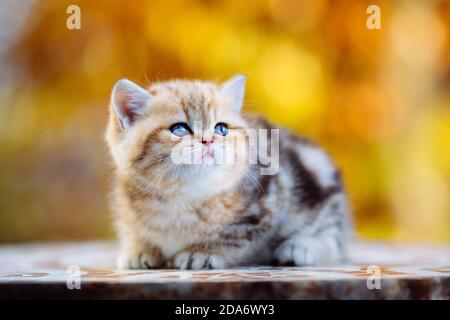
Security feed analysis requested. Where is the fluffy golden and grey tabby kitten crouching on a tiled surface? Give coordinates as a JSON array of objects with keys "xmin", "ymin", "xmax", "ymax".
[{"xmin": 106, "ymin": 76, "xmax": 351, "ymax": 269}]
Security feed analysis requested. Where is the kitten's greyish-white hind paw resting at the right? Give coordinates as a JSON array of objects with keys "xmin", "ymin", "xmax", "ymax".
[{"xmin": 275, "ymin": 237, "xmax": 341, "ymax": 266}]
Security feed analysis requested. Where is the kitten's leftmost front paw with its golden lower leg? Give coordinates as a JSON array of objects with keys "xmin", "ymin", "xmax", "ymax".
[{"xmin": 117, "ymin": 237, "xmax": 164, "ymax": 269}]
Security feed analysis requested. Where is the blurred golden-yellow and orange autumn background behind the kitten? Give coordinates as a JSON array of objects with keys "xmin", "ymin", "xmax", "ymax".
[{"xmin": 0, "ymin": 0, "xmax": 450, "ymax": 244}]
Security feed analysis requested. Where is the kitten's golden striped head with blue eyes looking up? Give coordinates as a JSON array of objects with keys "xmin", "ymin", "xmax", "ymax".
[{"xmin": 106, "ymin": 76, "xmax": 251, "ymax": 196}]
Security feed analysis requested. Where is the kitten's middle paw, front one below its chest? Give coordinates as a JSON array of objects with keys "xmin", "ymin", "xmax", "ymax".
[{"xmin": 173, "ymin": 251, "xmax": 225, "ymax": 270}]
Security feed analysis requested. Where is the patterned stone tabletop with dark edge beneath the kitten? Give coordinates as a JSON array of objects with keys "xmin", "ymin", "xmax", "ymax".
[{"xmin": 0, "ymin": 242, "xmax": 450, "ymax": 299}]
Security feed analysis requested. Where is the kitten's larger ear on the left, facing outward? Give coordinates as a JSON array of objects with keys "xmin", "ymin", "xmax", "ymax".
[{"xmin": 111, "ymin": 79, "xmax": 150, "ymax": 129}]
